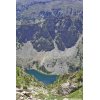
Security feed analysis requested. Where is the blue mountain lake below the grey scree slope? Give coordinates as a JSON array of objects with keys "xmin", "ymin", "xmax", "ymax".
[{"xmin": 26, "ymin": 69, "xmax": 58, "ymax": 85}]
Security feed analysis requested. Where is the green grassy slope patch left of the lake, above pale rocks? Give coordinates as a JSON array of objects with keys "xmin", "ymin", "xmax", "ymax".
[{"xmin": 16, "ymin": 67, "xmax": 42, "ymax": 89}]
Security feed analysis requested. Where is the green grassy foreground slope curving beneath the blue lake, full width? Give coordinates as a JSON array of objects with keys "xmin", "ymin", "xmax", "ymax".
[{"xmin": 16, "ymin": 67, "xmax": 83, "ymax": 100}]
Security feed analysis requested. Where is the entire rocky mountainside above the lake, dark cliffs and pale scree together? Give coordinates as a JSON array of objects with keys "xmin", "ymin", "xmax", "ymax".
[{"xmin": 16, "ymin": 0, "xmax": 83, "ymax": 74}]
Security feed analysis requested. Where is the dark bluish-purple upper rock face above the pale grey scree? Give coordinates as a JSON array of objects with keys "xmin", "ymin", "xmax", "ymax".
[{"xmin": 16, "ymin": 0, "xmax": 82, "ymax": 52}]
